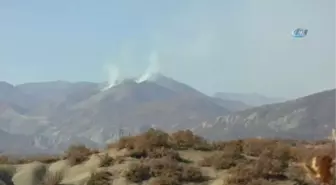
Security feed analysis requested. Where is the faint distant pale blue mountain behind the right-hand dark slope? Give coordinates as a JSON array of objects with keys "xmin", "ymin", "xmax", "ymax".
[{"xmin": 214, "ymin": 92, "xmax": 285, "ymax": 107}]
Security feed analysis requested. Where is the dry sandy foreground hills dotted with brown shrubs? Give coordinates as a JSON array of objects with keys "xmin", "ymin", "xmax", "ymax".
[{"xmin": 0, "ymin": 129, "xmax": 335, "ymax": 185}]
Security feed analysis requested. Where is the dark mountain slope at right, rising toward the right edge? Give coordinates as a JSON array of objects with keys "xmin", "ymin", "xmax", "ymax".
[{"xmin": 195, "ymin": 89, "xmax": 336, "ymax": 139}]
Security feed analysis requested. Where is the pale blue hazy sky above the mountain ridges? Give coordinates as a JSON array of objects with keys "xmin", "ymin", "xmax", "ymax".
[{"xmin": 0, "ymin": 0, "xmax": 336, "ymax": 98}]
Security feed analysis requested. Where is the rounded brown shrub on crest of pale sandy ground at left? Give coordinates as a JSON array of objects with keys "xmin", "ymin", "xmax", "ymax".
[{"xmin": 65, "ymin": 145, "xmax": 93, "ymax": 165}]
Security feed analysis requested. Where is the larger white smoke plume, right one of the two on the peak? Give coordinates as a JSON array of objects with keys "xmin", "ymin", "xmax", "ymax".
[{"xmin": 136, "ymin": 51, "xmax": 160, "ymax": 83}]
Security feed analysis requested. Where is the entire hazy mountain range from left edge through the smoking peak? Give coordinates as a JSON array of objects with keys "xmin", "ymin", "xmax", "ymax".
[{"xmin": 0, "ymin": 74, "xmax": 242, "ymax": 154}]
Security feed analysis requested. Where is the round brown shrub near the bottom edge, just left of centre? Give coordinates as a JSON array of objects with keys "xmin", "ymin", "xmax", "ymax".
[{"xmin": 125, "ymin": 163, "xmax": 150, "ymax": 183}]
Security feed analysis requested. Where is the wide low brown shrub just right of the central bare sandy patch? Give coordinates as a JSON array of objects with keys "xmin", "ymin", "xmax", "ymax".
[{"xmin": 200, "ymin": 151, "xmax": 245, "ymax": 169}]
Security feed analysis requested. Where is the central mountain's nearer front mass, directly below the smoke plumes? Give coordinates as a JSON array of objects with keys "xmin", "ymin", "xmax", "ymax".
[{"xmin": 47, "ymin": 80, "xmax": 229, "ymax": 143}]
